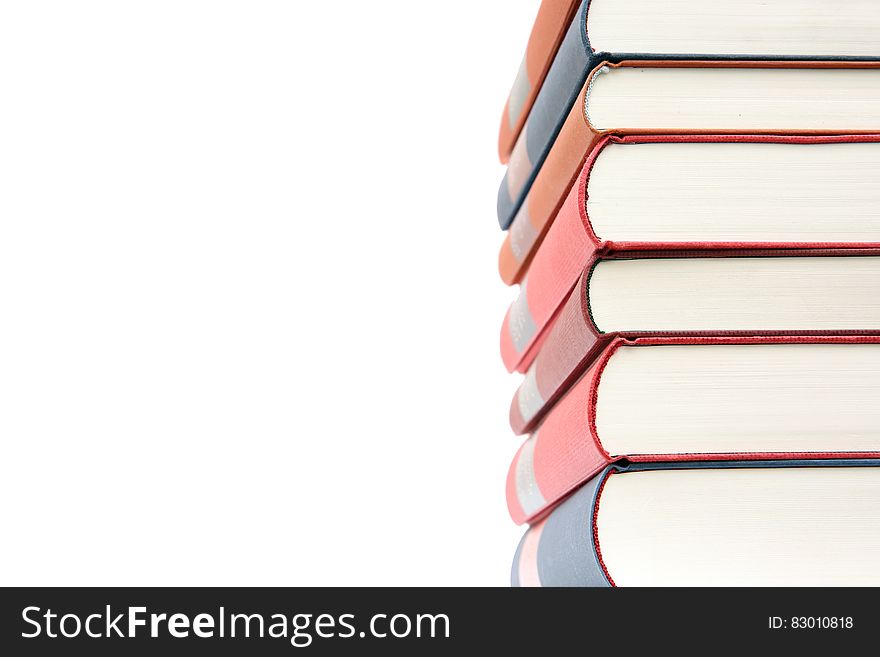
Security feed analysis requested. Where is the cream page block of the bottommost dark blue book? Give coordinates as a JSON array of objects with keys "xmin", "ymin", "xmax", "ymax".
[{"xmin": 596, "ymin": 468, "xmax": 880, "ymax": 586}]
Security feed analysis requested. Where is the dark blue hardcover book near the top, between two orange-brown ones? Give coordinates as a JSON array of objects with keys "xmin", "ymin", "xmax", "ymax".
[{"xmin": 498, "ymin": 0, "xmax": 880, "ymax": 229}]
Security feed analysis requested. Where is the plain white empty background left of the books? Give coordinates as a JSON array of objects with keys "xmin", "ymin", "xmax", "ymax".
[{"xmin": 0, "ymin": 0, "xmax": 539, "ymax": 585}]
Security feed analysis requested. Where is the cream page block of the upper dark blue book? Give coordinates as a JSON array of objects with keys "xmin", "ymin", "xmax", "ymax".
[{"xmin": 587, "ymin": 0, "xmax": 880, "ymax": 57}]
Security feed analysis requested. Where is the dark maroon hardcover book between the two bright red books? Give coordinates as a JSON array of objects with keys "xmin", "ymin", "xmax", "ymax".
[{"xmin": 511, "ymin": 251, "xmax": 880, "ymax": 430}]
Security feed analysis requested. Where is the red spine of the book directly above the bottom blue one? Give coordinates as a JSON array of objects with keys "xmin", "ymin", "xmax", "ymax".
[{"xmin": 506, "ymin": 354, "xmax": 611, "ymax": 524}]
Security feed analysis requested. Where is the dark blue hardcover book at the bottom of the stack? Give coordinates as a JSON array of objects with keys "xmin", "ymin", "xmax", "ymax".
[{"xmin": 511, "ymin": 459, "xmax": 880, "ymax": 587}]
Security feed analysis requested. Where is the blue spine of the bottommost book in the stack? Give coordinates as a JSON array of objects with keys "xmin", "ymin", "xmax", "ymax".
[{"xmin": 511, "ymin": 469, "xmax": 613, "ymax": 587}]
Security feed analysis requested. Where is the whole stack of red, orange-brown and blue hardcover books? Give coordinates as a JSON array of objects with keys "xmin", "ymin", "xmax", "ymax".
[{"xmin": 498, "ymin": 0, "xmax": 880, "ymax": 586}]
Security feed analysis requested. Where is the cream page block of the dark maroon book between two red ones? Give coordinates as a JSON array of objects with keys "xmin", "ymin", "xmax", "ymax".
[{"xmin": 588, "ymin": 256, "xmax": 880, "ymax": 332}]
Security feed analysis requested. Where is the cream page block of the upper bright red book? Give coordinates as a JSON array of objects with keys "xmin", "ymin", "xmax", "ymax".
[{"xmin": 587, "ymin": 141, "xmax": 880, "ymax": 242}]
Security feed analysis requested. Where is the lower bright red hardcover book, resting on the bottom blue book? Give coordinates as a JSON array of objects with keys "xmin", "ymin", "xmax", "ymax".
[{"xmin": 506, "ymin": 336, "xmax": 880, "ymax": 523}]
